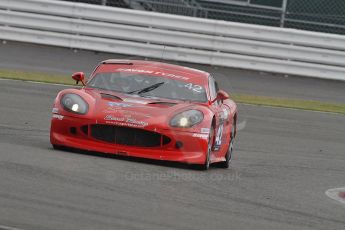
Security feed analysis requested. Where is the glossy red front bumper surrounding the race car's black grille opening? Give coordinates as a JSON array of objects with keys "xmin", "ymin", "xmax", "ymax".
[{"xmin": 50, "ymin": 114, "xmax": 208, "ymax": 164}]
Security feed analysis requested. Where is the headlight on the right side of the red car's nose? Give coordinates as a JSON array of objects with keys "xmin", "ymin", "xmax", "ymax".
[{"xmin": 170, "ymin": 110, "xmax": 204, "ymax": 128}]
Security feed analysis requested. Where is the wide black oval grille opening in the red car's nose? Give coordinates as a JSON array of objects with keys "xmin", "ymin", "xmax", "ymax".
[{"xmin": 90, "ymin": 124, "xmax": 171, "ymax": 147}]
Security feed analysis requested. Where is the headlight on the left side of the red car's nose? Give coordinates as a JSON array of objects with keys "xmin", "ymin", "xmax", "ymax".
[{"xmin": 61, "ymin": 93, "xmax": 89, "ymax": 114}]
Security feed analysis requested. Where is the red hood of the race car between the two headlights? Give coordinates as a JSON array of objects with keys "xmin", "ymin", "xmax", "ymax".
[{"xmin": 84, "ymin": 89, "xmax": 205, "ymax": 129}]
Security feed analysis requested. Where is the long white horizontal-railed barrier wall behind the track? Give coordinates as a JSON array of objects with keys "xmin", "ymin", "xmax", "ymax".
[{"xmin": 0, "ymin": 0, "xmax": 345, "ymax": 80}]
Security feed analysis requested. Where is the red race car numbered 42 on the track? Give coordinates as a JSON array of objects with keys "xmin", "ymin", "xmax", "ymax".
[{"xmin": 50, "ymin": 59, "xmax": 237, "ymax": 169}]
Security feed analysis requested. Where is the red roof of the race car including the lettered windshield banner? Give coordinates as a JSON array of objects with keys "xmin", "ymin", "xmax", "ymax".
[{"xmin": 95, "ymin": 59, "xmax": 210, "ymax": 86}]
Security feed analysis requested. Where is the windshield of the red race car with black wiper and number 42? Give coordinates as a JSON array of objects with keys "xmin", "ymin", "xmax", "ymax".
[{"xmin": 88, "ymin": 72, "xmax": 207, "ymax": 102}]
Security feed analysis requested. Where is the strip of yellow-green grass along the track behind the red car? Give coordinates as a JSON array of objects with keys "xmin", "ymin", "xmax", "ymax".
[{"xmin": 0, "ymin": 69, "xmax": 345, "ymax": 115}]
